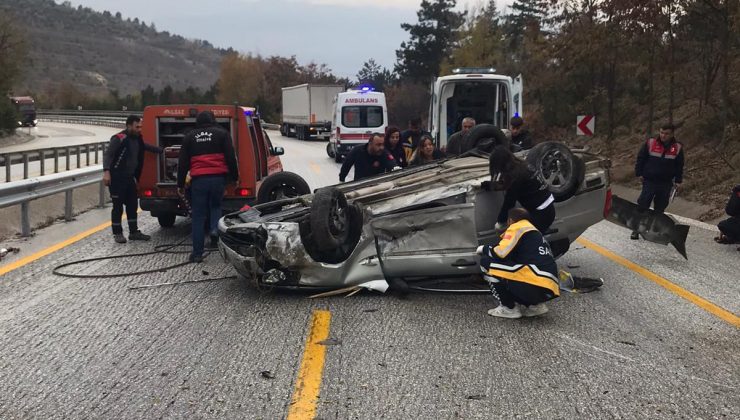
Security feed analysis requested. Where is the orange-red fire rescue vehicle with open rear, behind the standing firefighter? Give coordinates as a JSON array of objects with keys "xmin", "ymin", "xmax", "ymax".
[{"xmin": 138, "ymin": 105, "xmax": 310, "ymax": 227}]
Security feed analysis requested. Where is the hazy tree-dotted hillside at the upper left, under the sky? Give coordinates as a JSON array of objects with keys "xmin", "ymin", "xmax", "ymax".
[{"xmin": 0, "ymin": 0, "xmax": 226, "ymax": 96}]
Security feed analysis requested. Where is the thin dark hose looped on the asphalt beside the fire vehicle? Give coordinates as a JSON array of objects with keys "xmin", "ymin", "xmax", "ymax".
[{"xmin": 52, "ymin": 235, "xmax": 236, "ymax": 290}]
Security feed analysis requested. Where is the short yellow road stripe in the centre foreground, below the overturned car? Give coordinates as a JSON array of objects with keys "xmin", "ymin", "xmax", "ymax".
[{"xmin": 287, "ymin": 311, "xmax": 331, "ymax": 420}]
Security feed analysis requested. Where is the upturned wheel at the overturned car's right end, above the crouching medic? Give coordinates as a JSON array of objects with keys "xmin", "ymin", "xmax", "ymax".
[{"xmin": 526, "ymin": 141, "xmax": 586, "ymax": 202}]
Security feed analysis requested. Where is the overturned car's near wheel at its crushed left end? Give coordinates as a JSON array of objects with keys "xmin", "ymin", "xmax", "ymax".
[{"xmin": 310, "ymin": 187, "xmax": 351, "ymax": 251}]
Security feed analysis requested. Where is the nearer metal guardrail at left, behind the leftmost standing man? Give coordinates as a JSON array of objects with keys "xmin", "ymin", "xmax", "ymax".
[{"xmin": 0, "ymin": 165, "xmax": 105, "ymax": 236}]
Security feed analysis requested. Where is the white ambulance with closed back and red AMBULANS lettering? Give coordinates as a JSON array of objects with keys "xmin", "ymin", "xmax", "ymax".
[{"xmin": 326, "ymin": 87, "xmax": 388, "ymax": 162}]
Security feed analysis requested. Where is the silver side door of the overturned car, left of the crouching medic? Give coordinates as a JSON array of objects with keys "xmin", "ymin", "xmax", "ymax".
[{"xmin": 371, "ymin": 203, "xmax": 480, "ymax": 278}]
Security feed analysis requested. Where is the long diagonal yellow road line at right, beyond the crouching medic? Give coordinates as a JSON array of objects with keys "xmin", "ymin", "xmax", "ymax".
[{"xmin": 576, "ymin": 238, "xmax": 740, "ymax": 327}]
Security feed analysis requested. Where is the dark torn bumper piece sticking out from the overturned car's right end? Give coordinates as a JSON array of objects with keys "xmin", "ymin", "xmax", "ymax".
[{"xmin": 606, "ymin": 195, "xmax": 689, "ymax": 260}]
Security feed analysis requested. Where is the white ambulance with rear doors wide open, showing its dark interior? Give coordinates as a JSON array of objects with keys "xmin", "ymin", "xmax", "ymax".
[{"xmin": 429, "ymin": 68, "xmax": 523, "ymax": 152}]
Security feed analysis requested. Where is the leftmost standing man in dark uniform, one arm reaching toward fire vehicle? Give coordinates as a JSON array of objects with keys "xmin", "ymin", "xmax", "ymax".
[{"xmin": 103, "ymin": 115, "xmax": 163, "ymax": 244}]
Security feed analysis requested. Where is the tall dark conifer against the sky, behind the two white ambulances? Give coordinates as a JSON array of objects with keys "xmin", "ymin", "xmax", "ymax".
[{"xmin": 395, "ymin": 0, "xmax": 465, "ymax": 82}]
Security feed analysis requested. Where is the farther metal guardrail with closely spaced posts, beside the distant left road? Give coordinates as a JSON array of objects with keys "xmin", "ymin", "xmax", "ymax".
[{"xmin": 0, "ymin": 141, "xmax": 108, "ymax": 182}]
